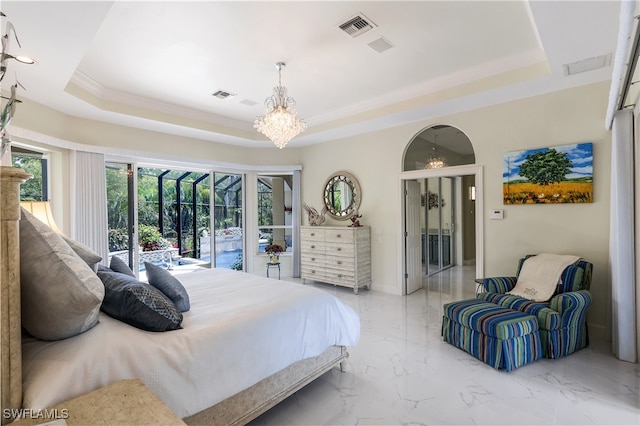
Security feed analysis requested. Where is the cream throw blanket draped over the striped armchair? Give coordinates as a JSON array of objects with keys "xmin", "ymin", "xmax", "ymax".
[{"xmin": 507, "ymin": 253, "xmax": 580, "ymax": 302}]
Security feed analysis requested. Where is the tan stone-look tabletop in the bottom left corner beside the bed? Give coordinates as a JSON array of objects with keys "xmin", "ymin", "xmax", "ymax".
[{"xmin": 11, "ymin": 379, "xmax": 186, "ymax": 426}]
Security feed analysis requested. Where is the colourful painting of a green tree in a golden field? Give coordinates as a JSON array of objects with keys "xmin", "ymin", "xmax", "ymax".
[{"xmin": 502, "ymin": 142, "xmax": 593, "ymax": 204}]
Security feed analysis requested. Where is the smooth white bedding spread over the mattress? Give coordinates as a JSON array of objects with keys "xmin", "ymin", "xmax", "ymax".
[{"xmin": 22, "ymin": 269, "xmax": 360, "ymax": 417}]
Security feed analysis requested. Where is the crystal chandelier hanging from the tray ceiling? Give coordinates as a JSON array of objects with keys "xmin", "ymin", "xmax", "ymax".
[{"xmin": 253, "ymin": 62, "xmax": 307, "ymax": 149}]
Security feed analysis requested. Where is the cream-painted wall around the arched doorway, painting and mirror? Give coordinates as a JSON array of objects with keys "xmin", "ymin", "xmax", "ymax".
[{"xmin": 8, "ymin": 82, "xmax": 610, "ymax": 332}]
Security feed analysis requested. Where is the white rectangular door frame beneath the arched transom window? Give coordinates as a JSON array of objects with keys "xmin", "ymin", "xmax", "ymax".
[{"xmin": 397, "ymin": 164, "xmax": 484, "ymax": 296}]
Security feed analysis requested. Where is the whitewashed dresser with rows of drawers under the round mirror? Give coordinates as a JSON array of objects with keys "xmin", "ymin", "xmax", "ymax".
[{"xmin": 300, "ymin": 226, "xmax": 371, "ymax": 294}]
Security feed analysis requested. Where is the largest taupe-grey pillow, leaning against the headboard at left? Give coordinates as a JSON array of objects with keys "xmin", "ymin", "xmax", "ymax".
[{"xmin": 20, "ymin": 209, "xmax": 104, "ymax": 340}]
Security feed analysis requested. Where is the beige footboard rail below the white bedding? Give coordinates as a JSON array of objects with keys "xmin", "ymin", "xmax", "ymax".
[{"xmin": 183, "ymin": 346, "xmax": 349, "ymax": 425}]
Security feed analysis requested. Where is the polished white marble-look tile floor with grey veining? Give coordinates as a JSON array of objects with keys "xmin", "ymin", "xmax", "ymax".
[{"xmin": 251, "ymin": 267, "xmax": 640, "ymax": 425}]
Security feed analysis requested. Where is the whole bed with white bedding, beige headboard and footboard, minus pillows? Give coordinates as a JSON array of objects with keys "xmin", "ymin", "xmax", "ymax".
[{"xmin": 0, "ymin": 167, "xmax": 360, "ymax": 424}]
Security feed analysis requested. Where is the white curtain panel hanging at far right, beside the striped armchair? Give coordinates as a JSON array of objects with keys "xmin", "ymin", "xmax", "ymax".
[{"xmin": 609, "ymin": 110, "xmax": 637, "ymax": 362}]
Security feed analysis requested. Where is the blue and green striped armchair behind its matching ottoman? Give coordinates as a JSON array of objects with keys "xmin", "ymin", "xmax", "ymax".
[{"xmin": 476, "ymin": 255, "xmax": 593, "ymax": 358}]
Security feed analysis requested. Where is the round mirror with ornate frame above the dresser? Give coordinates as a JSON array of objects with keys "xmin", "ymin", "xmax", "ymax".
[{"xmin": 324, "ymin": 171, "xmax": 362, "ymax": 220}]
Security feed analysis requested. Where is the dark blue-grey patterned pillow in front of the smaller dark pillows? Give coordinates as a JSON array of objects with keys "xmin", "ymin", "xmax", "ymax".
[{"xmin": 98, "ymin": 271, "xmax": 182, "ymax": 331}]
